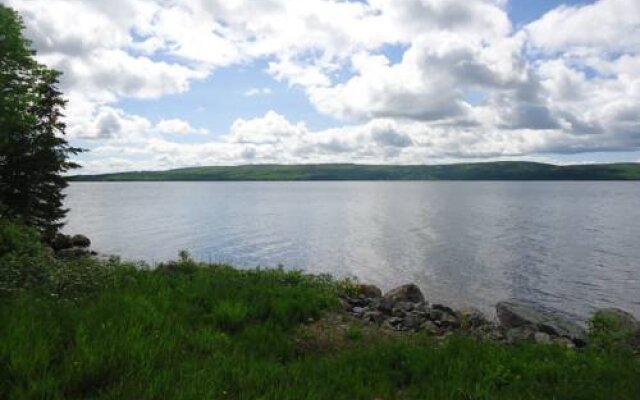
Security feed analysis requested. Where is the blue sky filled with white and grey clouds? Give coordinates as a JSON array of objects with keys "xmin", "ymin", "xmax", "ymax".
[{"xmin": 5, "ymin": 0, "xmax": 640, "ymax": 173}]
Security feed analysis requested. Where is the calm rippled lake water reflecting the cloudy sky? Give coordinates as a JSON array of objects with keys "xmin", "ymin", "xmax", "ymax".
[{"xmin": 65, "ymin": 182, "xmax": 640, "ymax": 319}]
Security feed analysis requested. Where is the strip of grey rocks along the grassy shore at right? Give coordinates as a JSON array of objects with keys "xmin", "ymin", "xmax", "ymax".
[{"xmin": 340, "ymin": 284, "xmax": 640, "ymax": 350}]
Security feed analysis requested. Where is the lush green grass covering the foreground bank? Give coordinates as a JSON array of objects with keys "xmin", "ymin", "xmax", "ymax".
[{"xmin": 0, "ymin": 220, "xmax": 640, "ymax": 400}]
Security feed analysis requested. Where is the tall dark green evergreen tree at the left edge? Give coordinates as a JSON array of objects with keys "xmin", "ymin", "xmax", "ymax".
[{"xmin": 0, "ymin": 5, "xmax": 81, "ymax": 237}]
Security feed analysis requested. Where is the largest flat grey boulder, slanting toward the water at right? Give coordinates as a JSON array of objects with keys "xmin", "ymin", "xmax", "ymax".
[{"xmin": 496, "ymin": 300, "xmax": 586, "ymax": 346}]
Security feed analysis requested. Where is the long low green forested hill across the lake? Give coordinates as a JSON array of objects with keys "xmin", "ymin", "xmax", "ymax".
[{"xmin": 71, "ymin": 161, "xmax": 640, "ymax": 181}]
